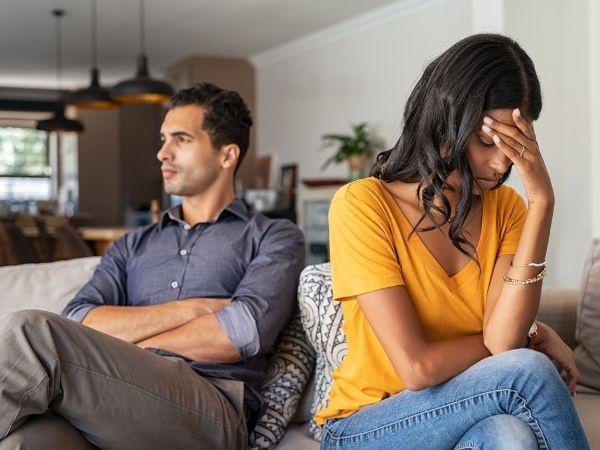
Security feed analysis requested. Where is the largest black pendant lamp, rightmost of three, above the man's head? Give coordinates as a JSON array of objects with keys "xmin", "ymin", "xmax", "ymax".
[{"xmin": 111, "ymin": 0, "xmax": 174, "ymax": 104}]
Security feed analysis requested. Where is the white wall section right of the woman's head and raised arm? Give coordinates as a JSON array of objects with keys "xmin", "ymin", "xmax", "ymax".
[{"xmin": 504, "ymin": 0, "xmax": 595, "ymax": 287}]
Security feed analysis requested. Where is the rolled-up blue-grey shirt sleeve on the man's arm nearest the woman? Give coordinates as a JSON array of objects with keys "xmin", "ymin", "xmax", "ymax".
[{"xmin": 216, "ymin": 220, "xmax": 304, "ymax": 359}]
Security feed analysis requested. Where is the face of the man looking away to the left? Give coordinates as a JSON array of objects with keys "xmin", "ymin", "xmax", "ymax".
[{"xmin": 156, "ymin": 105, "xmax": 221, "ymax": 196}]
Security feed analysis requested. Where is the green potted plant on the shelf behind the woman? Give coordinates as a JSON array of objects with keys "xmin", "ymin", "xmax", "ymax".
[{"xmin": 322, "ymin": 122, "xmax": 383, "ymax": 180}]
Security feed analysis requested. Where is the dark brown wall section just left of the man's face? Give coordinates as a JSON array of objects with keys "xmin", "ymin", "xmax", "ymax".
[{"xmin": 77, "ymin": 105, "xmax": 162, "ymax": 225}]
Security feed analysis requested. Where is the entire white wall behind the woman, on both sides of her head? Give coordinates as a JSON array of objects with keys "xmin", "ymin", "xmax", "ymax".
[{"xmin": 254, "ymin": 0, "xmax": 600, "ymax": 287}]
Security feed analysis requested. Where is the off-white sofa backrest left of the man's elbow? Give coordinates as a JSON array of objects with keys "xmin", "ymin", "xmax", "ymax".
[{"xmin": 0, "ymin": 256, "xmax": 100, "ymax": 321}]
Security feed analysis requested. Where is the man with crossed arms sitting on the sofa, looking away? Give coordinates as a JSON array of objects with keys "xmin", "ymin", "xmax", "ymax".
[{"xmin": 0, "ymin": 83, "xmax": 304, "ymax": 449}]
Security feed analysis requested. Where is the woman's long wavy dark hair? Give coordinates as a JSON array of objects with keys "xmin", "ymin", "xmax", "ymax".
[{"xmin": 371, "ymin": 34, "xmax": 542, "ymax": 260}]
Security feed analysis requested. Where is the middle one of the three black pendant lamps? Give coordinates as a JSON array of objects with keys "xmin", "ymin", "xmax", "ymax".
[{"xmin": 69, "ymin": 0, "xmax": 119, "ymax": 109}]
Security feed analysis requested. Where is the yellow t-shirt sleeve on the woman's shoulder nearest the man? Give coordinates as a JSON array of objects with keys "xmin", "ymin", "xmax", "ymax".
[{"xmin": 329, "ymin": 185, "xmax": 404, "ymax": 300}]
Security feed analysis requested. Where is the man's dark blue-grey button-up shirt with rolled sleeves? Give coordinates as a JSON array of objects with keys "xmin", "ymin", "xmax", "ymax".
[{"xmin": 63, "ymin": 199, "xmax": 304, "ymax": 420}]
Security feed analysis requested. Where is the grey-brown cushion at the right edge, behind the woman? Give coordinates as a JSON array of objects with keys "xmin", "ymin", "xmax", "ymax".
[{"xmin": 575, "ymin": 238, "xmax": 600, "ymax": 390}]
